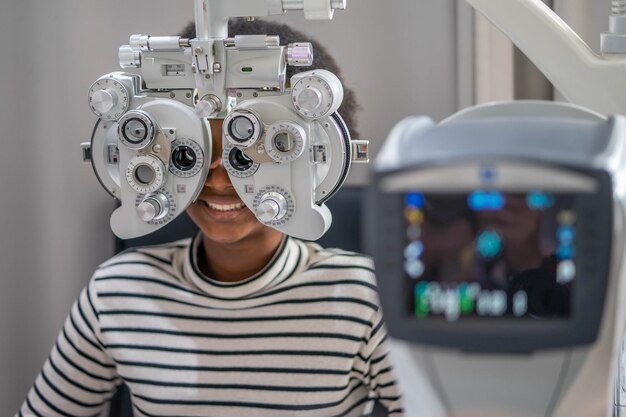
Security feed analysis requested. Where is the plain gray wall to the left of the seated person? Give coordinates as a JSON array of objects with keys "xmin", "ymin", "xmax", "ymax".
[{"xmin": 0, "ymin": 0, "xmax": 193, "ymax": 416}]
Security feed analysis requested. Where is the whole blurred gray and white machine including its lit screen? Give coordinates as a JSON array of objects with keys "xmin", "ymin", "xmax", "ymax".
[{"xmin": 366, "ymin": 102, "xmax": 626, "ymax": 417}]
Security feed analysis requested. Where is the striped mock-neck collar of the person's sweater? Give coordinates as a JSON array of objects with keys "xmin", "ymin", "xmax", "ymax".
[{"xmin": 184, "ymin": 233, "xmax": 304, "ymax": 299}]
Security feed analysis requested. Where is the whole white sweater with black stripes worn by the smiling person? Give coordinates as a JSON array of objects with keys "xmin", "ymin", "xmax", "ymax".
[{"xmin": 18, "ymin": 235, "xmax": 402, "ymax": 417}]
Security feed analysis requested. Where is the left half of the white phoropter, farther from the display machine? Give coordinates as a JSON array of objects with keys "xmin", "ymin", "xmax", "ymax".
[{"xmin": 84, "ymin": 73, "xmax": 211, "ymax": 238}]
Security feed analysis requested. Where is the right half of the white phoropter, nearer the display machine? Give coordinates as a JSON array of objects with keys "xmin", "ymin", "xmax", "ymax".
[{"xmin": 222, "ymin": 70, "xmax": 354, "ymax": 240}]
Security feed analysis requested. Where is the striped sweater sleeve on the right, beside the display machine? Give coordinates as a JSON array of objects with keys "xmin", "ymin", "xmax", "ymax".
[{"xmin": 363, "ymin": 308, "xmax": 404, "ymax": 417}]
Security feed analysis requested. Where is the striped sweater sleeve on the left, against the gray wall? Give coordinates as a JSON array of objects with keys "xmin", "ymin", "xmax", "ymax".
[{"xmin": 18, "ymin": 279, "xmax": 121, "ymax": 417}]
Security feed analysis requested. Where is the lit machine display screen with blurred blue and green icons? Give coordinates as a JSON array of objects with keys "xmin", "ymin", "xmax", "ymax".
[{"xmin": 403, "ymin": 190, "xmax": 577, "ymax": 321}]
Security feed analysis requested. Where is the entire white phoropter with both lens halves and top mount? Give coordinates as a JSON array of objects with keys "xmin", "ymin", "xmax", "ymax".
[{"xmin": 83, "ymin": 0, "xmax": 367, "ymax": 239}]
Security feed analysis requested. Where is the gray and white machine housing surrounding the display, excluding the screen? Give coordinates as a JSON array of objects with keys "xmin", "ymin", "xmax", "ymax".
[{"xmin": 367, "ymin": 103, "xmax": 626, "ymax": 417}]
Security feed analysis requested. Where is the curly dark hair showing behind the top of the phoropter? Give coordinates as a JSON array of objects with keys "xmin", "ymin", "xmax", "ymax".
[{"xmin": 180, "ymin": 18, "xmax": 359, "ymax": 137}]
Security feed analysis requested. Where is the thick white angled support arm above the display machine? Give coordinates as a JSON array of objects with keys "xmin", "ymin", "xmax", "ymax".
[{"xmin": 467, "ymin": 0, "xmax": 626, "ymax": 115}]
